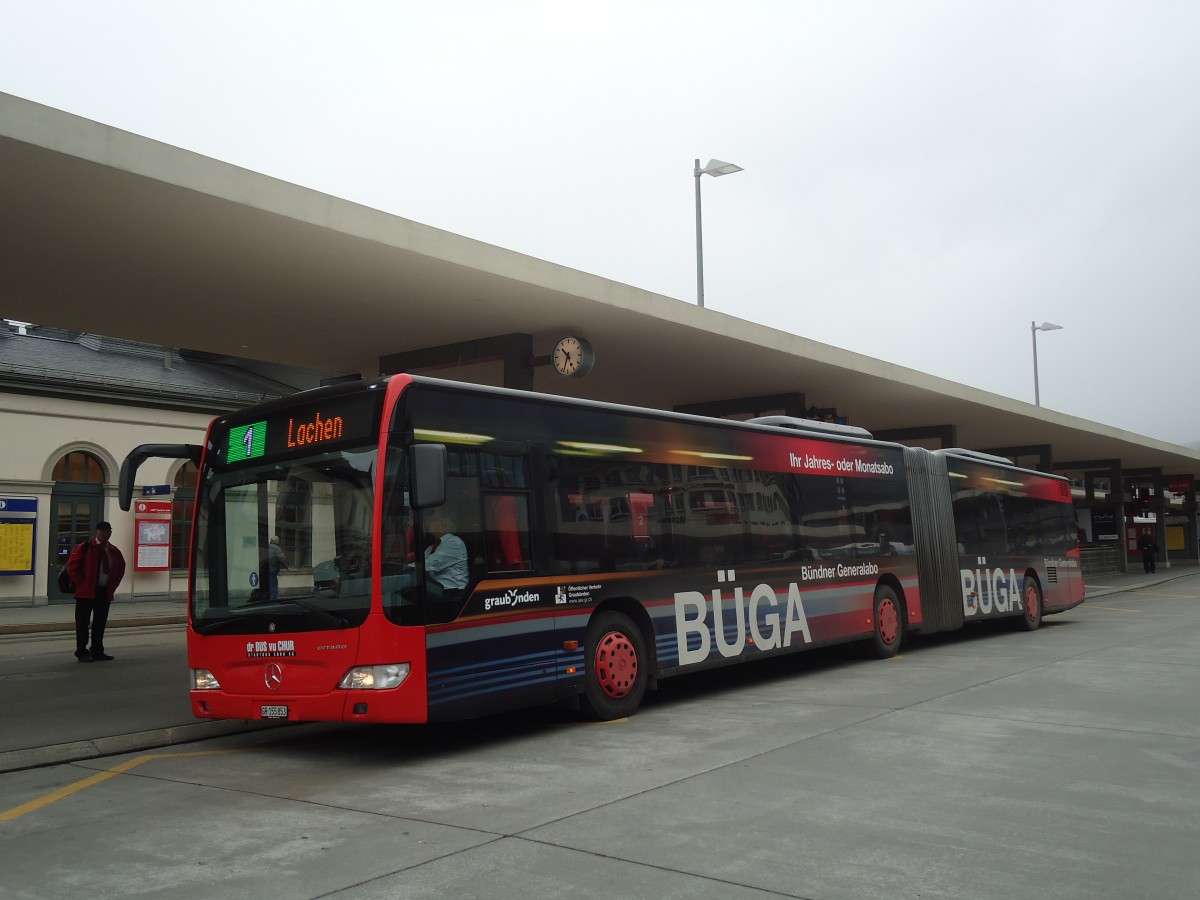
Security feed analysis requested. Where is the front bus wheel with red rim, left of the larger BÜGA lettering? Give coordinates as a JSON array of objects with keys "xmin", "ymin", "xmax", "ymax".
[{"xmin": 581, "ymin": 610, "xmax": 648, "ymax": 721}]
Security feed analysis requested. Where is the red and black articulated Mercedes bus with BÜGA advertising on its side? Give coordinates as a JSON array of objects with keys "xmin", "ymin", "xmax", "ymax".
[{"xmin": 121, "ymin": 374, "xmax": 1084, "ymax": 722}]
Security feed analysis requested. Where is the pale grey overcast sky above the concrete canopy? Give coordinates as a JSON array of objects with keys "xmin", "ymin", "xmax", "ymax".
[{"xmin": 0, "ymin": 0, "xmax": 1200, "ymax": 443}]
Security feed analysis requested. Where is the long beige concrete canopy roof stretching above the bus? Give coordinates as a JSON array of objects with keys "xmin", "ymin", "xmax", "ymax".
[{"xmin": 0, "ymin": 94, "xmax": 1200, "ymax": 474}]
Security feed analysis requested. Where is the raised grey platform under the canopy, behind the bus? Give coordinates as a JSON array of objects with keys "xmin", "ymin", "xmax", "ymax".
[{"xmin": 0, "ymin": 563, "xmax": 1200, "ymax": 772}]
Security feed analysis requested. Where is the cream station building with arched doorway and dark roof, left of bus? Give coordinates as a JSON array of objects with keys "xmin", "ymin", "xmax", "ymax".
[{"xmin": 0, "ymin": 322, "xmax": 320, "ymax": 606}]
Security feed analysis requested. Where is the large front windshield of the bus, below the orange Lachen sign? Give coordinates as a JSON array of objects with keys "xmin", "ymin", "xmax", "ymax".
[{"xmin": 191, "ymin": 445, "xmax": 378, "ymax": 634}]
